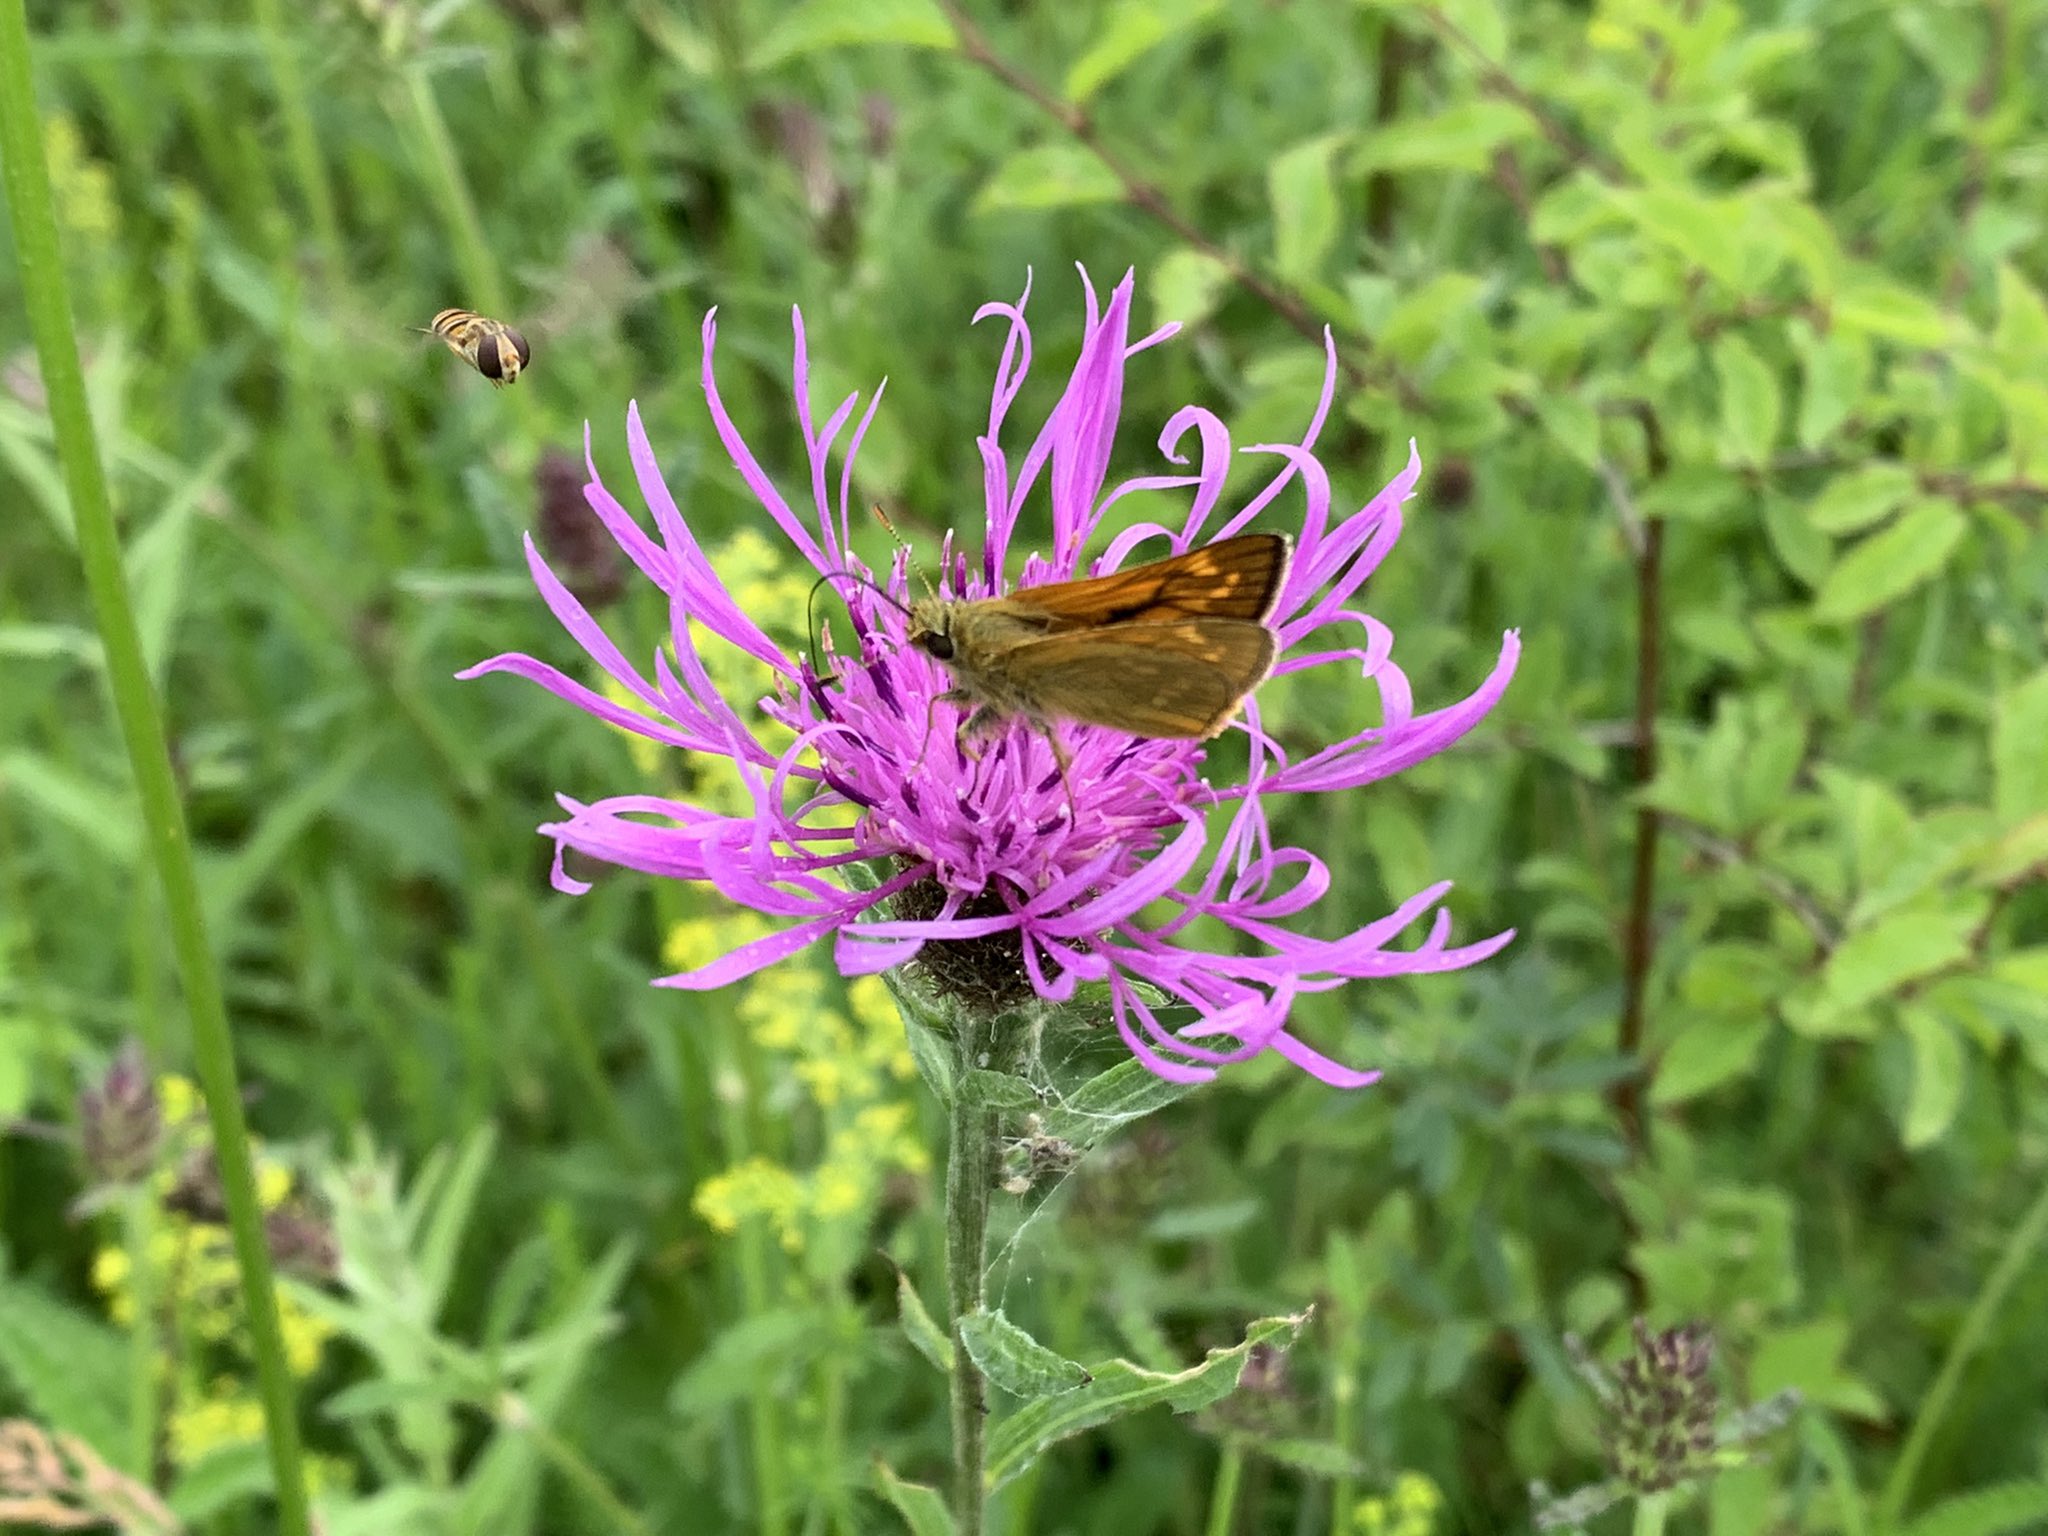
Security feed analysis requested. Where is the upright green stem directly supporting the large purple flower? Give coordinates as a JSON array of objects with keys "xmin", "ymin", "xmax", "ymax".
[{"xmin": 946, "ymin": 1010, "xmax": 999, "ymax": 1536}]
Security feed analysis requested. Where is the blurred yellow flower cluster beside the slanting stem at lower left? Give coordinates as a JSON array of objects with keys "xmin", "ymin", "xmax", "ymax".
[{"xmin": 92, "ymin": 1075, "xmax": 334, "ymax": 1466}]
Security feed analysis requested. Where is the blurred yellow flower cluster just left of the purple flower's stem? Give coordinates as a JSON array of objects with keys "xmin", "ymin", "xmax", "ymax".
[{"xmin": 664, "ymin": 911, "xmax": 930, "ymax": 1253}]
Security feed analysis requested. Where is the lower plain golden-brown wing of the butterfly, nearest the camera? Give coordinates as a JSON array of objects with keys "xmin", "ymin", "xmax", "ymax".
[{"xmin": 1004, "ymin": 618, "xmax": 1280, "ymax": 739}]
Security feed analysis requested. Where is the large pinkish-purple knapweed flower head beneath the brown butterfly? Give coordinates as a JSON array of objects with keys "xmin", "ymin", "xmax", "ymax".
[{"xmin": 461, "ymin": 272, "xmax": 1520, "ymax": 1087}]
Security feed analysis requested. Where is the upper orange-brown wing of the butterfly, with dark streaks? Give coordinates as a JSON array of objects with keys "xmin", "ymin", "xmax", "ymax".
[{"xmin": 1008, "ymin": 532, "xmax": 1292, "ymax": 631}]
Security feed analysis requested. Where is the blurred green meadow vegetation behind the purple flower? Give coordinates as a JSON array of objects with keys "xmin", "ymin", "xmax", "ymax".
[{"xmin": 0, "ymin": 0, "xmax": 2048, "ymax": 1536}]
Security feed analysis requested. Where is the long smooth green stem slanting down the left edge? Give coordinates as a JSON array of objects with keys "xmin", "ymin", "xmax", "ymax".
[{"xmin": 0, "ymin": 15, "xmax": 309, "ymax": 1536}]
